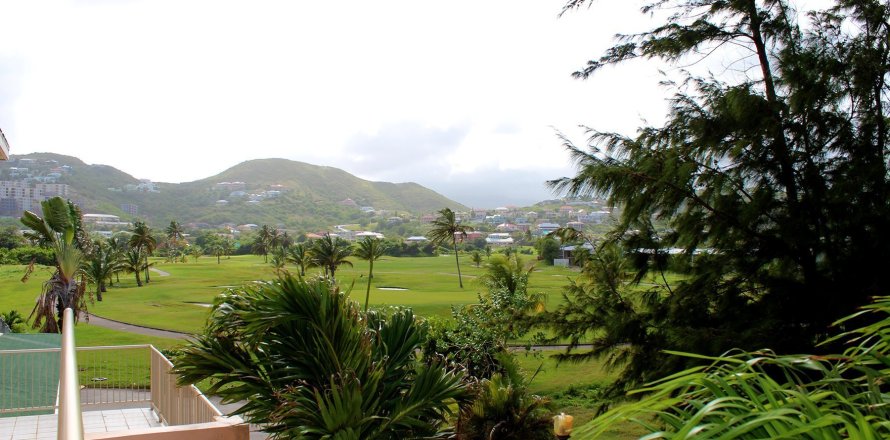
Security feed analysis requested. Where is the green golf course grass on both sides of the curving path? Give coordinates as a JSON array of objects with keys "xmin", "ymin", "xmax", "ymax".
[{"xmin": 0, "ymin": 254, "xmax": 660, "ymax": 439}]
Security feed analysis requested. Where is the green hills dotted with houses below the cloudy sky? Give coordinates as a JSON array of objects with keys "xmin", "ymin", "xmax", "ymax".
[{"xmin": 0, "ymin": 153, "xmax": 466, "ymax": 230}]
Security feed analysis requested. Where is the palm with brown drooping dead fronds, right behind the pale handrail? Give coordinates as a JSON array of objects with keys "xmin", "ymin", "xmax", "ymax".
[{"xmin": 21, "ymin": 197, "xmax": 90, "ymax": 333}]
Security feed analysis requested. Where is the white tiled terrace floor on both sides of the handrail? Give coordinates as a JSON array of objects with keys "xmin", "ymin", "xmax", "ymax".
[{"xmin": 0, "ymin": 408, "xmax": 161, "ymax": 440}]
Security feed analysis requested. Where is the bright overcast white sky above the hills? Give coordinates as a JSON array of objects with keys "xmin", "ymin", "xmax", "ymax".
[{"xmin": 0, "ymin": 0, "xmax": 688, "ymax": 207}]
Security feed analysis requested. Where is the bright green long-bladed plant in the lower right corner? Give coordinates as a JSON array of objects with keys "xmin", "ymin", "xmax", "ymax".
[{"xmin": 573, "ymin": 297, "xmax": 890, "ymax": 439}]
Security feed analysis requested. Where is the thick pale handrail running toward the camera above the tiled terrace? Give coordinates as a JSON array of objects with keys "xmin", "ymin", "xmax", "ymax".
[{"xmin": 56, "ymin": 308, "xmax": 83, "ymax": 440}]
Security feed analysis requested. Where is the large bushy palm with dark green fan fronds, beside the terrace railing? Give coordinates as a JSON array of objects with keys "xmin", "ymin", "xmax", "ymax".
[{"xmin": 169, "ymin": 275, "xmax": 468, "ymax": 440}]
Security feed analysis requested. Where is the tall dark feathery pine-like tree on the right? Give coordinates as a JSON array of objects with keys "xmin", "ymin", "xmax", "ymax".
[{"xmin": 551, "ymin": 0, "xmax": 890, "ymax": 390}]
